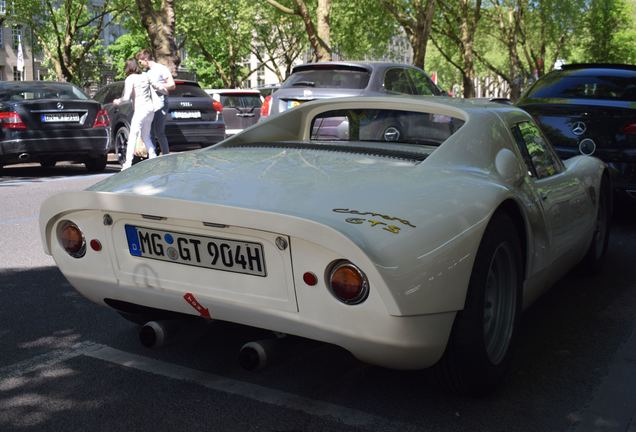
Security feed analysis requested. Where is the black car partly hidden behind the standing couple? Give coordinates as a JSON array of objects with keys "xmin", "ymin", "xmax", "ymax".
[{"xmin": 94, "ymin": 80, "xmax": 225, "ymax": 163}]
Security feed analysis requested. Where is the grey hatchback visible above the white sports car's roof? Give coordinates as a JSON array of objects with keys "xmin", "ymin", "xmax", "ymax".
[{"xmin": 261, "ymin": 62, "xmax": 447, "ymax": 119}]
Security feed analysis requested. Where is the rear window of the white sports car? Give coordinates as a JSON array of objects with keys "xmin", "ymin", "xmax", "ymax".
[{"xmin": 311, "ymin": 109, "xmax": 464, "ymax": 146}]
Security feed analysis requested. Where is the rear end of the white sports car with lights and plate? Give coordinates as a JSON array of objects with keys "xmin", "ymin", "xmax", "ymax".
[{"xmin": 40, "ymin": 192, "xmax": 455, "ymax": 369}]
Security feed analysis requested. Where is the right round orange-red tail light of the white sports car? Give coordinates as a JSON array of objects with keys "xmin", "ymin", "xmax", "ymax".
[{"xmin": 326, "ymin": 260, "xmax": 369, "ymax": 305}]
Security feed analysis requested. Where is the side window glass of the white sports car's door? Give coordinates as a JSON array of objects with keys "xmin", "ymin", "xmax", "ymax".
[{"xmin": 513, "ymin": 122, "xmax": 563, "ymax": 178}]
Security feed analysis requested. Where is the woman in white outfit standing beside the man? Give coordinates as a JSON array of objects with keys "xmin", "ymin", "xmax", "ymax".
[{"xmin": 113, "ymin": 59, "xmax": 157, "ymax": 170}]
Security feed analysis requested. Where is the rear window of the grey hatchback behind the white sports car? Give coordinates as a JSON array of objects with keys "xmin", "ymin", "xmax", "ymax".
[{"xmin": 282, "ymin": 69, "xmax": 371, "ymax": 89}]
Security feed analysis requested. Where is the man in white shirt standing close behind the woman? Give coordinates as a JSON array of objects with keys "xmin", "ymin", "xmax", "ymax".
[{"xmin": 135, "ymin": 49, "xmax": 176, "ymax": 155}]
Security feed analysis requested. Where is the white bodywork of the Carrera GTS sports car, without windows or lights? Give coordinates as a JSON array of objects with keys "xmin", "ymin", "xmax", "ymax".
[{"xmin": 40, "ymin": 98, "xmax": 604, "ymax": 369}]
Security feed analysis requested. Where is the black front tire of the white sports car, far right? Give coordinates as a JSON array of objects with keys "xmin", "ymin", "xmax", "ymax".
[{"xmin": 579, "ymin": 178, "xmax": 612, "ymax": 274}]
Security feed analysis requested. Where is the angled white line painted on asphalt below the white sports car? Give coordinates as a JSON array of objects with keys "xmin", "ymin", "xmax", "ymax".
[{"xmin": 0, "ymin": 342, "xmax": 416, "ymax": 431}]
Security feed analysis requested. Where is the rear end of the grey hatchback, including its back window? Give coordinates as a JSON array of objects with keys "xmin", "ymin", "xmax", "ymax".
[{"xmin": 261, "ymin": 63, "xmax": 372, "ymax": 118}]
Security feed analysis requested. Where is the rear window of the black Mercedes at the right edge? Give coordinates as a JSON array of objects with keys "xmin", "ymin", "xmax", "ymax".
[{"xmin": 527, "ymin": 75, "xmax": 636, "ymax": 101}]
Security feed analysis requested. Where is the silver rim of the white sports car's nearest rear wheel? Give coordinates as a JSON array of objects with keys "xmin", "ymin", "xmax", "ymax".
[{"xmin": 484, "ymin": 243, "xmax": 519, "ymax": 365}]
